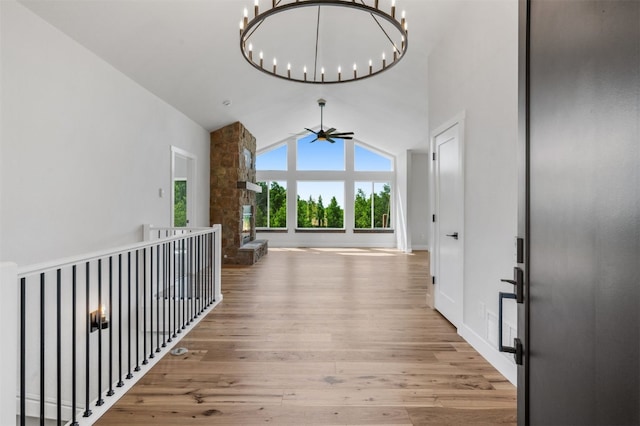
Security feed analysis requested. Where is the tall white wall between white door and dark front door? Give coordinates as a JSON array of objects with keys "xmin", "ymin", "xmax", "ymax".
[{"xmin": 428, "ymin": 0, "xmax": 518, "ymax": 382}]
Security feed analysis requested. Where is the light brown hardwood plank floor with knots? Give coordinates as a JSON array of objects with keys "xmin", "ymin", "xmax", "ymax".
[{"xmin": 97, "ymin": 249, "xmax": 516, "ymax": 425}]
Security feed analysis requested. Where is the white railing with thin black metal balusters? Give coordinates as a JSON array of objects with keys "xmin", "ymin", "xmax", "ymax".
[{"xmin": 10, "ymin": 225, "xmax": 222, "ymax": 425}]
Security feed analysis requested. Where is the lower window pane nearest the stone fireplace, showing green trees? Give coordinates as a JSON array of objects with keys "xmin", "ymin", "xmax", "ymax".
[{"xmin": 256, "ymin": 181, "xmax": 287, "ymax": 228}]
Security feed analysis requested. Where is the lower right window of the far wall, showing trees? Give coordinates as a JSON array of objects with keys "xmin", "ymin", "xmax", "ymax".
[{"xmin": 353, "ymin": 182, "xmax": 391, "ymax": 229}]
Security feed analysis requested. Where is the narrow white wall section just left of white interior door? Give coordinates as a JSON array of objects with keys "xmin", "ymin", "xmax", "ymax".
[{"xmin": 408, "ymin": 152, "xmax": 431, "ymax": 250}]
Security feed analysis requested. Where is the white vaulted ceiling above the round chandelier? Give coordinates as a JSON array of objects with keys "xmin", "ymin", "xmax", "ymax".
[{"xmin": 21, "ymin": 0, "xmax": 461, "ymax": 153}]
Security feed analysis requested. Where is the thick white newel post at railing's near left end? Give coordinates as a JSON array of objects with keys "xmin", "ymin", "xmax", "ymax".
[{"xmin": 0, "ymin": 262, "xmax": 20, "ymax": 425}]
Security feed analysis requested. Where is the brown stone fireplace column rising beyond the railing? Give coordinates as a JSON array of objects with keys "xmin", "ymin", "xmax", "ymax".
[{"xmin": 209, "ymin": 122, "xmax": 256, "ymax": 264}]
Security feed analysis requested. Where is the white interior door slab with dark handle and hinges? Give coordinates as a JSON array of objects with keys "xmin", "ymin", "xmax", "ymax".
[{"xmin": 433, "ymin": 124, "xmax": 464, "ymax": 327}]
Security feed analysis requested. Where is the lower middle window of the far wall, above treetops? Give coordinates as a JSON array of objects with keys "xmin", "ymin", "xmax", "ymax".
[{"xmin": 297, "ymin": 181, "xmax": 344, "ymax": 229}]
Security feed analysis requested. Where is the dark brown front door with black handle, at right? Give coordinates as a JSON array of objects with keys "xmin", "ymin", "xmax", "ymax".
[{"xmin": 519, "ymin": 0, "xmax": 640, "ymax": 425}]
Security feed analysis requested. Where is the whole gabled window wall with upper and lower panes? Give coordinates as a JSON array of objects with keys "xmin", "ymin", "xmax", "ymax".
[{"xmin": 255, "ymin": 134, "xmax": 395, "ymax": 234}]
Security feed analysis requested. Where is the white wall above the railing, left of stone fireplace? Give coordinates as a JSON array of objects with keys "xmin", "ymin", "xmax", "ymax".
[{"xmin": 0, "ymin": 1, "xmax": 209, "ymax": 265}]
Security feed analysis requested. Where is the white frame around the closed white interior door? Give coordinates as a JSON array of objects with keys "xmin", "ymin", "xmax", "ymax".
[{"xmin": 430, "ymin": 111, "xmax": 465, "ymax": 328}]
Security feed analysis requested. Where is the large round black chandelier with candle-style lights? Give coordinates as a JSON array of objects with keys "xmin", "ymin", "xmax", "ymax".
[{"xmin": 240, "ymin": 0, "xmax": 409, "ymax": 84}]
